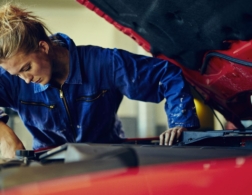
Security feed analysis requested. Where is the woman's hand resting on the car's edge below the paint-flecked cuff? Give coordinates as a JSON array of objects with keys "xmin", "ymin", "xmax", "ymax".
[{"xmin": 159, "ymin": 127, "xmax": 187, "ymax": 146}]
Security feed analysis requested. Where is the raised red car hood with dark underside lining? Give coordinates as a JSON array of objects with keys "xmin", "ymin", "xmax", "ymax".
[{"xmin": 77, "ymin": 0, "xmax": 252, "ymax": 129}]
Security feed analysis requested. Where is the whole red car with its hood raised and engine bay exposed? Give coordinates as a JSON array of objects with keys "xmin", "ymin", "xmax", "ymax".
[{"xmin": 0, "ymin": 0, "xmax": 252, "ymax": 195}]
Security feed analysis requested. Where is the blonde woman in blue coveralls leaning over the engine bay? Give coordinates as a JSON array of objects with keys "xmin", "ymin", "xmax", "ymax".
[{"xmin": 0, "ymin": 4, "xmax": 199, "ymax": 157}]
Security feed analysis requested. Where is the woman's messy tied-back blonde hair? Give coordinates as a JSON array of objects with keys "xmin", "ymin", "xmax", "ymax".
[{"xmin": 0, "ymin": 3, "xmax": 51, "ymax": 61}]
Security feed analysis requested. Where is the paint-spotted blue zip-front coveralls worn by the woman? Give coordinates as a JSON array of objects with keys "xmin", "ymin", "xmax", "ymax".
[{"xmin": 0, "ymin": 33, "xmax": 199, "ymax": 149}]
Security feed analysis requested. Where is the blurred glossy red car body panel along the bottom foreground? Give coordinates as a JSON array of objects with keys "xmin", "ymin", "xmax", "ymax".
[{"xmin": 3, "ymin": 157, "xmax": 252, "ymax": 195}]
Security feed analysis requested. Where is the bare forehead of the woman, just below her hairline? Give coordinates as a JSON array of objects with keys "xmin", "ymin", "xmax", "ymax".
[{"xmin": 0, "ymin": 53, "xmax": 29, "ymax": 74}]
